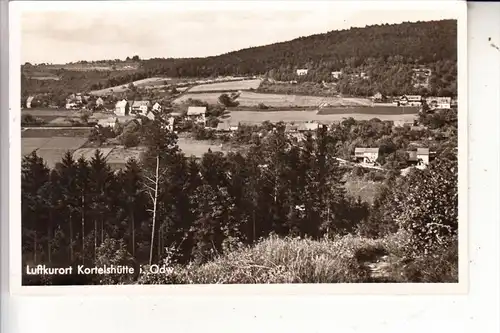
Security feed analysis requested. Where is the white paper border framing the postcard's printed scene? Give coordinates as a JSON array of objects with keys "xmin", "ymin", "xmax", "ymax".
[{"xmin": 9, "ymin": 1, "xmax": 468, "ymax": 296}]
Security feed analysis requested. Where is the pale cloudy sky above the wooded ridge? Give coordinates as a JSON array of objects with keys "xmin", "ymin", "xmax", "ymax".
[{"xmin": 20, "ymin": 1, "xmax": 456, "ymax": 64}]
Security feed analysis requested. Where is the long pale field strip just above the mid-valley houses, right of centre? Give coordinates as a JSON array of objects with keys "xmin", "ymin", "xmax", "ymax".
[{"xmin": 228, "ymin": 111, "xmax": 417, "ymax": 124}]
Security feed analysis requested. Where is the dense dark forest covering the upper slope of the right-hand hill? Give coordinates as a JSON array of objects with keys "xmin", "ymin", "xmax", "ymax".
[{"xmin": 143, "ymin": 20, "xmax": 457, "ymax": 76}]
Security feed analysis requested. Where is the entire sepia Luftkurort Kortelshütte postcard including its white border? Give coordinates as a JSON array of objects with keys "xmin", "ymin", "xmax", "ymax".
[{"xmin": 11, "ymin": 1, "xmax": 467, "ymax": 291}]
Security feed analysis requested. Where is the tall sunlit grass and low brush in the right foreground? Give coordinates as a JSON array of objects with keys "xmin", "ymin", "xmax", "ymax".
[{"xmin": 138, "ymin": 232, "xmax": 458, "ymax": 284}]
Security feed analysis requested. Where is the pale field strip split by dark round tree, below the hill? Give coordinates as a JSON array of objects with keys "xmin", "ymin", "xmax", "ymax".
[{"xmin": 174, "ymin": 91, "xmax": 371, "ymax": 107}]
